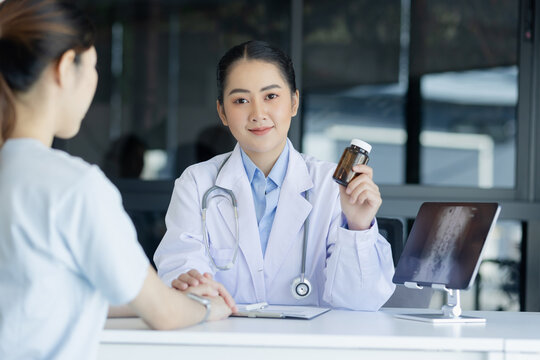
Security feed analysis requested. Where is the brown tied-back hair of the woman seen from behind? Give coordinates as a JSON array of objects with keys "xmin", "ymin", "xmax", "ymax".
[{"xmin": 0, "ymin": 0, "xmax": 94, "ymax": 145}]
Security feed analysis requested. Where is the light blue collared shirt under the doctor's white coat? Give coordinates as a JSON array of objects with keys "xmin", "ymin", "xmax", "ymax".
[{"xmin": 240, "ymin": 143, "xmax": 289, "ymax": 256}]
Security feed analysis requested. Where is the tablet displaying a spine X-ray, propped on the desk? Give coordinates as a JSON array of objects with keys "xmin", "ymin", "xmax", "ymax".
[{"xmin": 393, "ymin": 202, "xmax": 499, "ymax": 290}]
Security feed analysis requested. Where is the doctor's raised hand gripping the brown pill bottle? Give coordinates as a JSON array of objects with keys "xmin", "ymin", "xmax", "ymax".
[{"xmin": 339, "ymin": 165, "xmax": 382, "ymax": 230}]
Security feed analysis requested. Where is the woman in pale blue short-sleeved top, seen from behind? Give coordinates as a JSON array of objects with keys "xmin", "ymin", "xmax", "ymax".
[{"xmin": 0, "ymin": 0, "xmax": 235, "ymax": 360}]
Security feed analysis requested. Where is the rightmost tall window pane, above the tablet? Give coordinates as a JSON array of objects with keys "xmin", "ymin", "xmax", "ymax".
[{"xmin": 411, "ymin": 0, "xmax": 519, "ymax": 188}]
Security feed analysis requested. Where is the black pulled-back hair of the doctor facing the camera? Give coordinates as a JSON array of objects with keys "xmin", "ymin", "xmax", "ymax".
[{"xmin": 217, "ymin": 40, "xmax": 296, "ymax": 105}]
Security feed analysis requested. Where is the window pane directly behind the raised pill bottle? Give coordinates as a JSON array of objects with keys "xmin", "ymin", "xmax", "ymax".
[{"xmin": 302, "ymin": 0, "xmax": 407, "ymax": 184}]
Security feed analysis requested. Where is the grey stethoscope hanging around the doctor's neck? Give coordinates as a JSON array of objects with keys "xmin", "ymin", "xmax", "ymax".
[{"xmin": 201, "ymin": 155, "xmax": 311, "ymax": 299}]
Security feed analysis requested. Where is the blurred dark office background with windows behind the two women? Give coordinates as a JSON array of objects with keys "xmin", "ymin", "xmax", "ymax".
[{"xmin": 55, "ymin": 0, "xmax": 540, "ymax": 311}]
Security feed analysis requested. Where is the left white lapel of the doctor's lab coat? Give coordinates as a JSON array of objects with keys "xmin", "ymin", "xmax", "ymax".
[{"xmin": 216, "ymin": 144, "xmax": 264, "ymax": 296}]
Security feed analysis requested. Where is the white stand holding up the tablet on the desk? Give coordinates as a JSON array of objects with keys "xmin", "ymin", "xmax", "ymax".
[{"xmin": 395, "ymin": 282, "xmax": 486, "ymax": 323}]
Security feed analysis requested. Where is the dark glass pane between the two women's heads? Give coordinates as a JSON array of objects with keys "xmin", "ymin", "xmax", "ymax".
[{"xmin": 71, "ymin": 0, "xmax": 290, "ymax": 180}]
